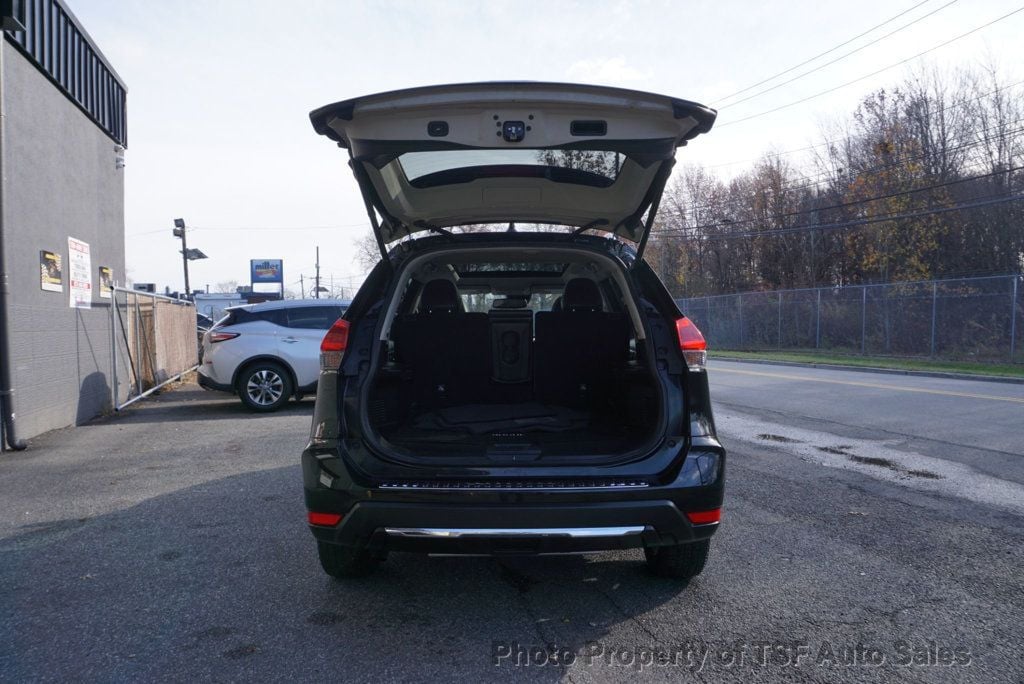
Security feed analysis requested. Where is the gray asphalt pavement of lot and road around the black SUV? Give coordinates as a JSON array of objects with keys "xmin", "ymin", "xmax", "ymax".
[{"xmin": 0, "ymin": 362, "xmax": 1024, "ymax": 682}]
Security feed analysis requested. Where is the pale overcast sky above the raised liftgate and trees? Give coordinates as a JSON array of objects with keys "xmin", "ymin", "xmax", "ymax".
[{"xmin": 68, "ymin": 0, "xmax": 1024, "ymax": 291}]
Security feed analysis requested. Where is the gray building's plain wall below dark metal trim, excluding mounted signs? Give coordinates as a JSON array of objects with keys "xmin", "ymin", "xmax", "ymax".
[{"xmin": 0, "ymin": 39, "xmax": 125, "ymax": 438}]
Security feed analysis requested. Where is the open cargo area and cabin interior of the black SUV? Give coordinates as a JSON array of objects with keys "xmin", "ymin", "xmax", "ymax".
[{"xmin": 368, "ymin": 252, "xmax": 658, "ymax": 456}]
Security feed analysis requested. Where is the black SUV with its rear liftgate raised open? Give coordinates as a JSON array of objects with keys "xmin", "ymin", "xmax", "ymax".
[{"xmin": 302, "ymin": 83, "xmax": 725, "ymax": 581}]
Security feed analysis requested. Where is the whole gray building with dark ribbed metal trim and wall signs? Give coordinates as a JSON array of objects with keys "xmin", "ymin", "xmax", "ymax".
[{"xmin": 0, "ymin": 0, "xmax": 127, "ymax": 447}]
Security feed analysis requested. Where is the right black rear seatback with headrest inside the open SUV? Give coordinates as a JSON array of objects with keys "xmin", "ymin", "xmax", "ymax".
[{"xmin": 534, "ymin": 277, "xmax": 630, "ymax": 407}]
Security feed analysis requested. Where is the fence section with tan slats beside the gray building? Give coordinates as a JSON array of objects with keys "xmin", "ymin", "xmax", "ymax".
[{"xmin": 111, "ymin": 288, "xmax": 199, "ymax": 411}]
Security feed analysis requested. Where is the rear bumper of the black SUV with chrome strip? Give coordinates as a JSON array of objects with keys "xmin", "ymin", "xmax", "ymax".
[{"xmin": 302, "ymin": 447, "xmax": 725, "ymax": 555}]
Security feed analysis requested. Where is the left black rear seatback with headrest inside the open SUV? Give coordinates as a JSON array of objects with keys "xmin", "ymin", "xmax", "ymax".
[{"xmin": 391, "ymin": 281, "xmax": 490, "ymax": 408}]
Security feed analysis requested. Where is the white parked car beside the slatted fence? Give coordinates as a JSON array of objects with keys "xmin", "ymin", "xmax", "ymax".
[{"xmin": 199, "ymin": 299, "xmax": 349, "ymax": 412}]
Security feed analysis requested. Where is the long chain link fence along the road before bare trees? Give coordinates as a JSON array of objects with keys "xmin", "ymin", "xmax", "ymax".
[{"xmin": 677, "ymin": 275, "xmax": 1024, "ymax": 362}]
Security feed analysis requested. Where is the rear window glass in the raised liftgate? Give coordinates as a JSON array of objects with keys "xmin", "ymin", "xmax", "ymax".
[{"xmin": 398, "ymin": 149, "xmax": 625, "ymax": 181}]
